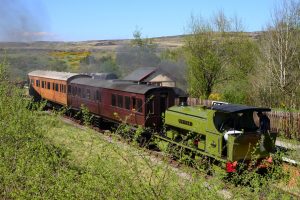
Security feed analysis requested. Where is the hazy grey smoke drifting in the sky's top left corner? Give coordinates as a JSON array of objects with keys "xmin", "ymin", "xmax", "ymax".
[{"xmin": 0, "ymin": 0, "xmax": 52, "ymax": 42}]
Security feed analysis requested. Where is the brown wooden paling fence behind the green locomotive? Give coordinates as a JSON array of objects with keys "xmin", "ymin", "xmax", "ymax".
[{"xmin": 176, "ymin": 98, "xmax": 300, "ymax": 140}]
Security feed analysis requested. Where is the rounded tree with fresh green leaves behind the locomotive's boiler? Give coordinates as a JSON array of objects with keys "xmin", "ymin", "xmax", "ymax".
[{"xmin": 183, "ymin": 11, "xmax": 255, "ymax": 98}]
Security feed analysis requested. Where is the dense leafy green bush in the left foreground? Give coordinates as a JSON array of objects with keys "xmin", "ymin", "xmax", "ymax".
[{"xmin": 0, "ymin": 61, "xmax": 77, "ymax": 199}]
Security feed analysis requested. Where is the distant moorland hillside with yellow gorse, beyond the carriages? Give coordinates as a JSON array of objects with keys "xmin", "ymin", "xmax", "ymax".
[{"xmin": 0, "ymin": 32, "xmax": 260, "ymax": 81}]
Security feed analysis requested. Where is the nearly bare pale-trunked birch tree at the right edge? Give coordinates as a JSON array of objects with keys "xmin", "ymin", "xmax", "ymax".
[{"xmin": 257, "ymin": 0, "xmax": 300, "ymax": 107}]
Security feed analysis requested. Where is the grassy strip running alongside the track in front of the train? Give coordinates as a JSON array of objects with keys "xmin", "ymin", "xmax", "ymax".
[{"xmin": 41, "ymin": 113, "xmax": 222, "ymax": 199}]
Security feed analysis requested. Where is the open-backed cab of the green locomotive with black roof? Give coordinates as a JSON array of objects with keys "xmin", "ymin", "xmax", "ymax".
[{"xmin": 213, "ymin": 104, "xmax": 276, "ymax": 161}]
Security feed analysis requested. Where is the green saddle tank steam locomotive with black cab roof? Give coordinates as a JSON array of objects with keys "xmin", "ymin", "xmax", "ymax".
[{"xmin": 165, "ymin": 101, "xmax": 276, "ymax": 169}]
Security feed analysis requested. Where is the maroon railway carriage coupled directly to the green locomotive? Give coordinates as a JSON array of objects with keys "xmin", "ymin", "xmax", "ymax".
[{"xmin": 68, "ymin": 78, "xmax": 176, "ymax": 127}]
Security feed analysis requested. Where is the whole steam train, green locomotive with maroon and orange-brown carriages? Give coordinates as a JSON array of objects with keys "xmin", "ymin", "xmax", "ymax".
[{"xmin": 28, "ymin": 70, "xmax": 276, "ymax": 172}]
